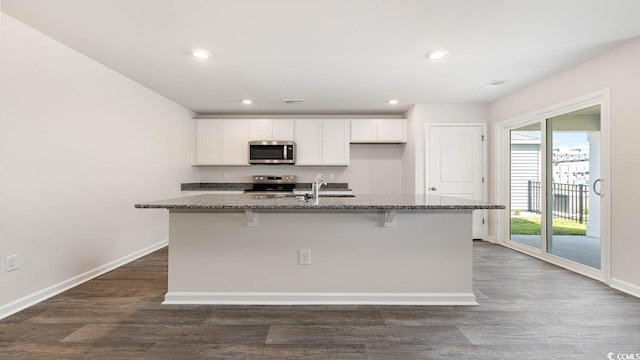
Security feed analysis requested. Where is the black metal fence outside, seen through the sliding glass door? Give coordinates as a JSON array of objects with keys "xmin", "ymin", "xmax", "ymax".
[{"xmin": 527, "ymin": 181, "xmax": 589, "ymax": 224}]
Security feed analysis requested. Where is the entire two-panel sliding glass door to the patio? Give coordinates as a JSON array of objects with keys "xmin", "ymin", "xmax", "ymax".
[{"xmin": 509, "ymin": 105, "xmax": 601, "ymax": 269}]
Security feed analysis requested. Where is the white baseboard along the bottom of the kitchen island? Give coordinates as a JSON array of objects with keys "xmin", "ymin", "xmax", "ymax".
[{"xmin": 163, "ymin": 292, "xmax": 478, "ymax": 305}]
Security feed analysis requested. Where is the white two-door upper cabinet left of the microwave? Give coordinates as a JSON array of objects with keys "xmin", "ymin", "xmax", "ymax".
[{"xmin": 195, "ymin": 119, "xmax": 249, "ymax": 165}]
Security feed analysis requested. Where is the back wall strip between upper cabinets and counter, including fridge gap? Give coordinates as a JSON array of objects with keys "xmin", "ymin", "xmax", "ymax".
[{"xmin": 198, "ymin": 144, "xmax": 404, "ymax": 194}]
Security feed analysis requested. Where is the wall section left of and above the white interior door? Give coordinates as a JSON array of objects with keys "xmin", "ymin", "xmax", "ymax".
[{"xmin": 402, "ymin": 104, "xmax": 489, "ymax": 194}]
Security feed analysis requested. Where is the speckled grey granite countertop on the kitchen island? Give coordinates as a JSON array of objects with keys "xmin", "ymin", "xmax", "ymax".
[{"xmin": 135, "ymin": 194, "xmax": 506, "ymax": 210}]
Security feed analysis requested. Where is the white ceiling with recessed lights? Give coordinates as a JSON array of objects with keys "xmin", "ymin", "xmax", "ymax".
[{"xmin": 1, "ymin": 0, "xmax": 640, "ymax": 114}]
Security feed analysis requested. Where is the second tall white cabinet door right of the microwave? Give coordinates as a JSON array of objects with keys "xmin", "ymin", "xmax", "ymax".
[{"xmin": 322, "ymin": 120, "xmax": 350, "ymax": 166}]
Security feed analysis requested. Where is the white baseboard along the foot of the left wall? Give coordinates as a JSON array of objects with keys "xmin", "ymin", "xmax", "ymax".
[{"xmin": 0, "ymin": 239, "xmax": 169, "ymax": 320}]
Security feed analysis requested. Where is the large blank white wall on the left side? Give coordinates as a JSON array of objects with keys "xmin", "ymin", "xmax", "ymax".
[{"xmin": 0, "ymin": 14, "xmax": 195, "ymax": 318}]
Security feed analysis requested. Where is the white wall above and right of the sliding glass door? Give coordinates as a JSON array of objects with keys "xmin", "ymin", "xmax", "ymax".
[{"xmin": 489, "ymin": 39, "xmax": 640, "ymax": 293}]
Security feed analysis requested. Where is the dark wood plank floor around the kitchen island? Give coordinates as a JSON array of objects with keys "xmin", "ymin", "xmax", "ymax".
[{"xmin": 0, "ymin": 241, "xmax": 640, "ymax": 360}]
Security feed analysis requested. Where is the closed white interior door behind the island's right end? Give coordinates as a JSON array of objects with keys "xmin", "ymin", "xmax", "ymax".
[{"xmin": 425, "ymin": 125, "xmax": 486, "ymax": 239}]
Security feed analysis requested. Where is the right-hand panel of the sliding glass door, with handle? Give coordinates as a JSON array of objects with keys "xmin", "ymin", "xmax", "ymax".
[{"xmin": 545, "ymin": 106, "xmax": 601, "ymax": 269}]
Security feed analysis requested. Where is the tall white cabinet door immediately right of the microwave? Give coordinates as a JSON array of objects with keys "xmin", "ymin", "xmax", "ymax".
[{"xmin": 295, "ymin": 119, "xmax": 322, "ymax": 165}]
